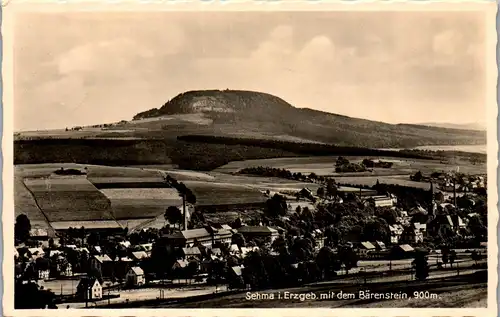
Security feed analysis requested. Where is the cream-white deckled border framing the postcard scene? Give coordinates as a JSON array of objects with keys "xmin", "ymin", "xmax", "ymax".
[{"xmin": 2, "ymin": 0, "xmax": 498, "ymax": 317}]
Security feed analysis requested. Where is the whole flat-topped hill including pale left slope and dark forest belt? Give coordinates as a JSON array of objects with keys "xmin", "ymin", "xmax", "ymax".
[{"xmin": 14, "ymin": 90, "xmax": 486, "ymax": 170}]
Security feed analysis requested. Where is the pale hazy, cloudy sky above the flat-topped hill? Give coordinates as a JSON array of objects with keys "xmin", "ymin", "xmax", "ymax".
[{"xmin": 14, "ymin": 11, "xmax": 486, "ymax": 131}]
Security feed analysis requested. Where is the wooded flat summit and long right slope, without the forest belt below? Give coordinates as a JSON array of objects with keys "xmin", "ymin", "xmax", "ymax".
[{"xmin": 133, "ymin": 90, "xmax": 486, "ymax": 148}]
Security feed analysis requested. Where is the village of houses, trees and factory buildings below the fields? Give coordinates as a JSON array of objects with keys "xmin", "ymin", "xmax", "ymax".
[{"xmin": 14, "ymin": 160, "xmax": 487, "ymax": 308}]
